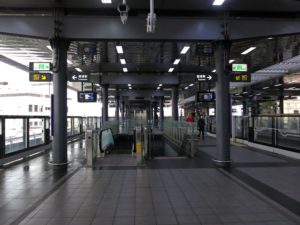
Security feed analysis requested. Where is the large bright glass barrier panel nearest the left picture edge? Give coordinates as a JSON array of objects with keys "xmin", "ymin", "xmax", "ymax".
[{"xmin": 5, "ymin": 118, "xmax": 27, "ymax": 154}]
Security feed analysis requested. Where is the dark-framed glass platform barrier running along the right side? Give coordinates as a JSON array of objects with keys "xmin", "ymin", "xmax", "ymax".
[{"xmin": 208, "ymin": 115, "xmax": 300, "ymax": 152}]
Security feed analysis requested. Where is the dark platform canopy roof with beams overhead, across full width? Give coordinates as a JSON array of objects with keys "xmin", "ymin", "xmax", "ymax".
[{"xmin": 0, "ymin": 0, "xmax": 300, "ymax": 103}]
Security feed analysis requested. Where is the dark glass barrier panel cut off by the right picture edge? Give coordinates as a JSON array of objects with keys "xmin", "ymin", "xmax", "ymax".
[{"xmin": 276, "ymin": 117, "xmax": 300, "ymax": 151}]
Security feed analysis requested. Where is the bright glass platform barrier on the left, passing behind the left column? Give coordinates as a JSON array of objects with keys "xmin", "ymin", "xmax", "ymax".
[{"xmin": 0, "ymin": 116, "xmax": 83, "ymax": 158}]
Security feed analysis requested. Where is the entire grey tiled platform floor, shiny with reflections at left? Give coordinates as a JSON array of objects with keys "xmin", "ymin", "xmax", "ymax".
[{"xmin": 0, "ymin": 137, "xmax": 300, "ymax": 225}]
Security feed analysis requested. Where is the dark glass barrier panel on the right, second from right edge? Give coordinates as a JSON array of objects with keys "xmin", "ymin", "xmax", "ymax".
[{"xmin": 254, "ymin": 116, "xmax": 273, "ymax": 145}]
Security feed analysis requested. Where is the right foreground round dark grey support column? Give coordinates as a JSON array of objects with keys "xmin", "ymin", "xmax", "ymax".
[{"xmin": 214, "ymin": 42, "xmax": 231, "ymax": 167}]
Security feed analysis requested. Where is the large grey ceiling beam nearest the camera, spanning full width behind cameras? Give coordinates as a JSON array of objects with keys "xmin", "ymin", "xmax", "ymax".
[{"xmin": 0, "ymin": 16, "xmax": 300, "ymax": 41}]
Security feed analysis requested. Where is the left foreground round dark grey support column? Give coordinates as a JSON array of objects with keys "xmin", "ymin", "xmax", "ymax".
[{"xmin": 51, "ymin": 38, "xmax": 69, "ymax": 168}]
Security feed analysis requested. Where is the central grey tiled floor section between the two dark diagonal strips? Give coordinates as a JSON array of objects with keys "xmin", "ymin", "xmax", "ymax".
[{"xmin": 22, "ymin": 168, "xmax": 296, "ymax": 225}]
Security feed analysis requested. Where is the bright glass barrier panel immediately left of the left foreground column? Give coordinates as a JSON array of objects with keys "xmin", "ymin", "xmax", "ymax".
[{"xmin": 29, "ymin": 118, "xmax": 45, "ymax": 147}]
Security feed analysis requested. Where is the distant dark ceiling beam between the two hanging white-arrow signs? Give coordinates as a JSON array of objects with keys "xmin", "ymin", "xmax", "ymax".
[{"xmin": 100, "ymin": 74, "xmax": 179, "ymax": 85}]
